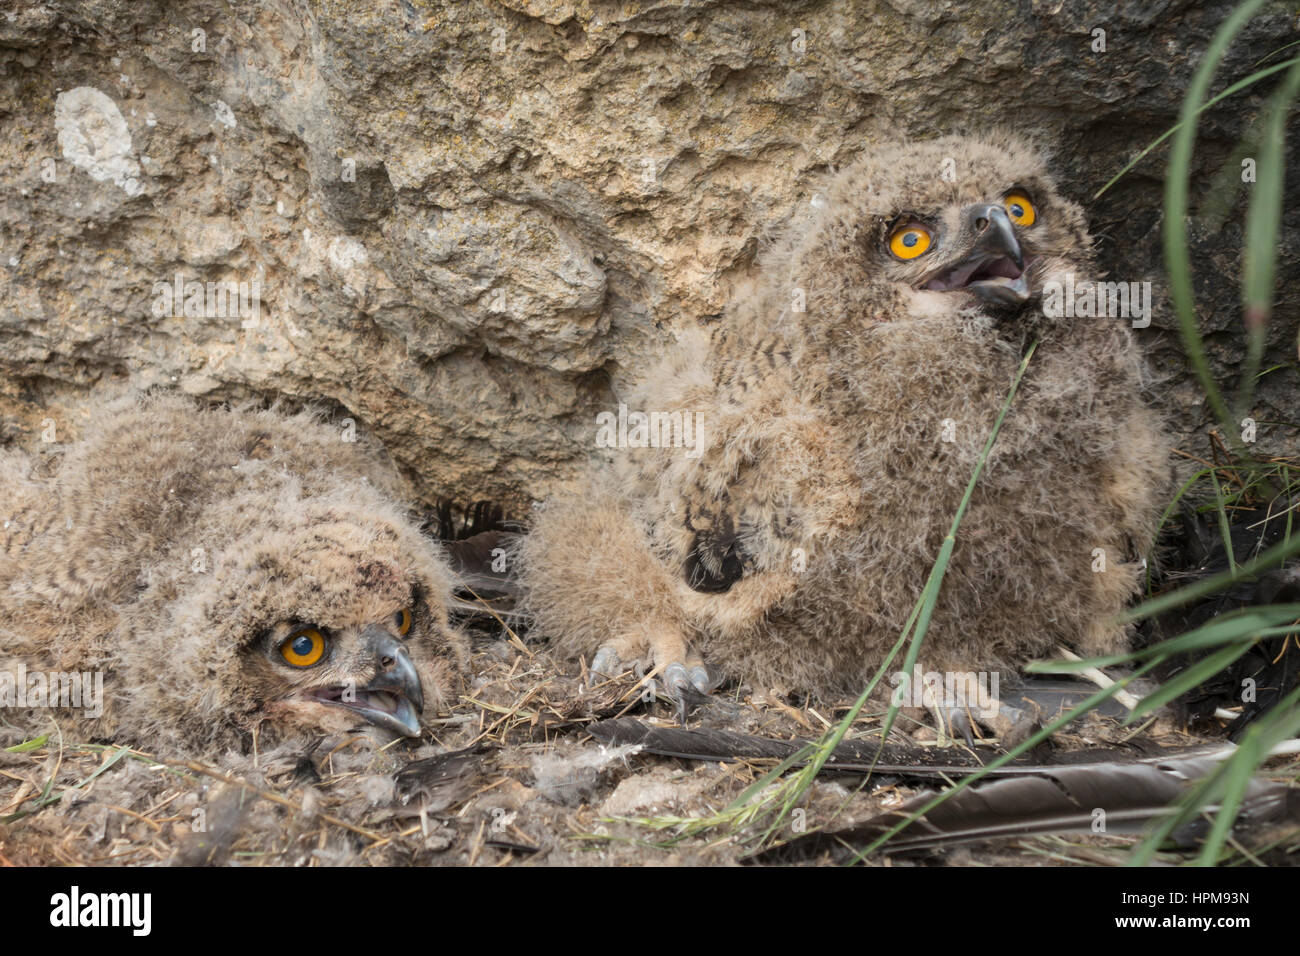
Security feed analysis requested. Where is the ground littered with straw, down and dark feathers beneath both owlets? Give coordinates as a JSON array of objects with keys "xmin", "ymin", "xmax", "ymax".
[{"xmin": 0, "ymin": 486, "xmax": 1300, "ymax": 866}]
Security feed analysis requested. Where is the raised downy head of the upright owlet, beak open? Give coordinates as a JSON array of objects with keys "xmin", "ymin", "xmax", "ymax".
[{"xmin": 774, "ymin": 137, "xmax": 1091, "ymax": 329}]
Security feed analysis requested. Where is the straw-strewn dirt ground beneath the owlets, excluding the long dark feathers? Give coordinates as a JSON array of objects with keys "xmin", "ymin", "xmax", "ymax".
[{"xmin": 0, "ymin": 606, "xmax": 1297, "ymax": 866}]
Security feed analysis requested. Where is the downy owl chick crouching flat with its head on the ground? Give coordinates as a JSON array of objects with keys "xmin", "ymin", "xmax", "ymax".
[{"xmin": 0, "ymin": 397, "xmax": 467, "ymax": 752}]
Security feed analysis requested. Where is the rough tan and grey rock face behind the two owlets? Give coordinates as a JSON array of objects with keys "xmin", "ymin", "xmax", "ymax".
[{"xmin": 0, "ymin": 0, "xmax": 1300, "ymax": 511}]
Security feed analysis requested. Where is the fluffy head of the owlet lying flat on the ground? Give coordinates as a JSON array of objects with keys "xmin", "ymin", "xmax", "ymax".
[{"xmin": 152, "ymin": 489, "xmax": 467, "ymax": 739}]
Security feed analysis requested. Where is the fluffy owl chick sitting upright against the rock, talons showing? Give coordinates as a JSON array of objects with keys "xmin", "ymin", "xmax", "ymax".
[{"xmin": 519, "ymin": 135, "xmax": 1169, "ymax": 695}]
